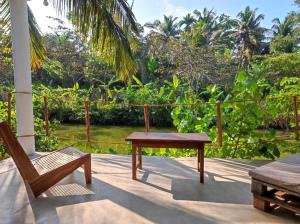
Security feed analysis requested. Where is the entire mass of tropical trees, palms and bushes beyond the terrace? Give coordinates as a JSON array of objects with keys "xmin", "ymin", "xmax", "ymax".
[{"xmin": 0, "ymin": 3, "xmax": 300, "ymax": 159}]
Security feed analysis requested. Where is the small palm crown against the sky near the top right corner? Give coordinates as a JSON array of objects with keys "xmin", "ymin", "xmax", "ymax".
[{"xmin": 272, "ymin": 14, "xmax": 296, "ymax": 37}]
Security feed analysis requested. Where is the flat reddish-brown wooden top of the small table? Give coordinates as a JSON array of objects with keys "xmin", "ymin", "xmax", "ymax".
[{"xmin": 125, "ymin": 132, "xmax": 211, "ymax": 143}]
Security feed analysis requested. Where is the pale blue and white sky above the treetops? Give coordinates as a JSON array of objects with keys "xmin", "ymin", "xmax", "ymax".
[{"xmin": 28, "ymin": 0, "xmax": 299, "ymax": 32}]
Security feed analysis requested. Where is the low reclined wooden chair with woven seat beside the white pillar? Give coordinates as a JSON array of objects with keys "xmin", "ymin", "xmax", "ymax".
[{"xmin": 0, "ymin": 121, "xmax": 91, "ymax": 197}]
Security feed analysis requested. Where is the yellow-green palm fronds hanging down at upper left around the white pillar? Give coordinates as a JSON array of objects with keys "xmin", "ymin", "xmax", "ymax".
[{"xmin": 0, "ymin": 0, "xmax": 138, "ymax": 79}]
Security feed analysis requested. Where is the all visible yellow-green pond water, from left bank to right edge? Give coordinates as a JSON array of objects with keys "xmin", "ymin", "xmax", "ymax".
[{"xmin": 54, "ymin": 124, "xmax": 300, "ymax": 159}]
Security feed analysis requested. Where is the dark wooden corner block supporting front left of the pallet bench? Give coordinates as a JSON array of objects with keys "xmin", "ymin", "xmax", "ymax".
[{"xmin": 251, "ymin": 179, "xmax": 270, "ymax": 211}]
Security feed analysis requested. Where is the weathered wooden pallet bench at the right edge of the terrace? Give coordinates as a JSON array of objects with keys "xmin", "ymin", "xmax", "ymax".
[{"xmin": 249, "ymin": 154, "xmax": 300, "ymax": 214}]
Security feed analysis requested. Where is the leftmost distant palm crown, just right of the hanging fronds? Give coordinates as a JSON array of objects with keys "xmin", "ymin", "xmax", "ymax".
[{"xmin": 144, "ymin": 15, "xmax": 180, "ymax": 38}]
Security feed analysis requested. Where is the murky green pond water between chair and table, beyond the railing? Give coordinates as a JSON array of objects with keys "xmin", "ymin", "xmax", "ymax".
[{"xmin": 54, "ymin": 124, "xmax": 177, "ymax": 154}]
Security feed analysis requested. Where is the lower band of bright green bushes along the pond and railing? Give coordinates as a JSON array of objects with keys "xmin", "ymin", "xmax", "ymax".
[{"xmin": 0, "ymin": 70, "xmax": 300, "ymax": 159}]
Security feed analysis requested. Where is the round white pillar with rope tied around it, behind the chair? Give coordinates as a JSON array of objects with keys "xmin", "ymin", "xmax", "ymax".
[{"xmin": 9, "ymin": 0, "xmax": 35, "ymax": 154}]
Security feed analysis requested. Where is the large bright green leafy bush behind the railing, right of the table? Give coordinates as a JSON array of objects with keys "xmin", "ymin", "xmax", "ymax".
[{"xmin": 172, "ymin": 70, "xmax": 299, "ymax": 159}]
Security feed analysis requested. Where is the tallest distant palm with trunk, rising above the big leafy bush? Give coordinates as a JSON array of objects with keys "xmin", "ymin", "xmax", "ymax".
[{"xmin": 231, "ymin": 6, "xmax": 267, "ymax": 68}]
